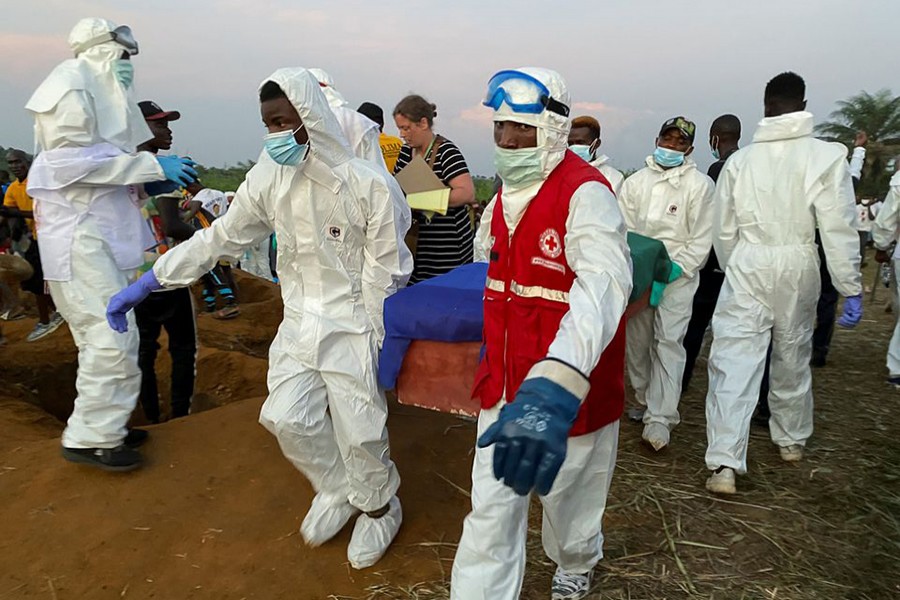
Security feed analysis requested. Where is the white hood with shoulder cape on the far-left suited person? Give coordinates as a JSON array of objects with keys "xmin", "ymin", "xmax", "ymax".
[{"xmin": 25, "ymin": 17, "xmax": 153, "ymax": 153}]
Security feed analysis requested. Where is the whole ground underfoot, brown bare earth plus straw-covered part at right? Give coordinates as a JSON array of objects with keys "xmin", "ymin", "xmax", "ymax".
[{"xmin": 0, "ymin": 276, "xmax": 900, "ymax": 600}]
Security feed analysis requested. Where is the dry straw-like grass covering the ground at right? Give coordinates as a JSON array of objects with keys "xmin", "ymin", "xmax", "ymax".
[{"xmin": 335, "ymin": 266, "xmax": 900, "ymax": 600}]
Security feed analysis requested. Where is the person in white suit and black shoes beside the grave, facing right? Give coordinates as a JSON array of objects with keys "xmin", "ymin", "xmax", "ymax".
[{"xmin": 26, "ymin": 18, "xmax": 196, "ymax": 470}]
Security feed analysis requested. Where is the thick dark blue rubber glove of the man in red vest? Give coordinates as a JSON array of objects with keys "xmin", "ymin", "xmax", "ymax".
[{"xmin": 478, "ymin": 360, "xmax": 589, "ymax": 496}]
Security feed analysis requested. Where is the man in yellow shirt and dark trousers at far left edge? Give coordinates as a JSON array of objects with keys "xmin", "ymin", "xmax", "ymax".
[{"xmin": 0, "ymin": 150, "xmax": 63, "ymax": 342}]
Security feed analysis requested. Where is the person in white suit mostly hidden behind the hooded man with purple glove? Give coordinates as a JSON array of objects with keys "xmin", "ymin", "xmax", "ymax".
[{"xmin": 309, "ymin": 68, "xmax": 413, "ymax": 287}]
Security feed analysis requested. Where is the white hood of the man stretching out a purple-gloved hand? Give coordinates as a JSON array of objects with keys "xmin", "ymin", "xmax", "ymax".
[{"xmin": 260, "ymin": 67, "xmax": 353, "ymax": 170}]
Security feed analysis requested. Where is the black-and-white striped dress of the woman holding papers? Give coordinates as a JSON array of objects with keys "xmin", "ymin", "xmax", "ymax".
[{"xmin": 394, "ymin": 138, "xmax": 474, "ymax": 284}]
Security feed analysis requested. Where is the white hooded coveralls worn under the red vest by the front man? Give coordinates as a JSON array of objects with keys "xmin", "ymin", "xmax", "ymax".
[{"xmin": 451, "ymin": 68, "xmax": 632, "ymax": 600}]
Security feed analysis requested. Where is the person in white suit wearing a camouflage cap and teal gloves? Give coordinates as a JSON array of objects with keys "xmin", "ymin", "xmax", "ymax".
[{"xmin": 619, "ymin": 117, "xmax": 714, "ymax": 451}]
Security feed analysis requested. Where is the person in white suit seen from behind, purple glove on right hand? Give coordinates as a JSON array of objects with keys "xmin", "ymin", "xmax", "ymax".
[{"xmin": 706, "ymin": 73, "xmax": 862, "ymax": 494}]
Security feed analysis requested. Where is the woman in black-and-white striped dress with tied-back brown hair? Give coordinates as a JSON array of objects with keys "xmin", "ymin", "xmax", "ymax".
[{"xmin": 394, "ymin": 95, "xmax": 475, "ymax": 284}]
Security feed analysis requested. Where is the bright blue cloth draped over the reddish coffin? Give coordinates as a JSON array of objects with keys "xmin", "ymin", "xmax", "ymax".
[{"xmin": 378, "ymin": 263, "xmax": 487, "ymax": 389}]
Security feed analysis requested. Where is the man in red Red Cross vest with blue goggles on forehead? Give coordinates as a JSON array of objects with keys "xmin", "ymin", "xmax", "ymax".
[{"xmin": 451, "ymin": 68, "xmax": 632, "ymax": 600}]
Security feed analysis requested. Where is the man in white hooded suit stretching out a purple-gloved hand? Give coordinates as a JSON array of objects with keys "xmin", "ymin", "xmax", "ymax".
[{"xmin": 109, "ymin": 68, "xmax": 410, "ymax": 569}]
